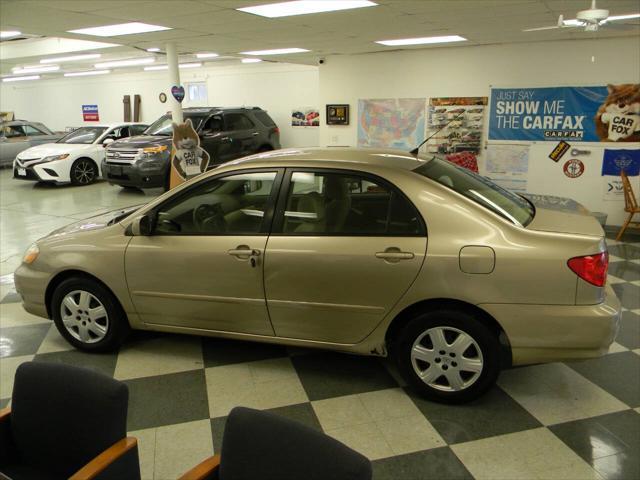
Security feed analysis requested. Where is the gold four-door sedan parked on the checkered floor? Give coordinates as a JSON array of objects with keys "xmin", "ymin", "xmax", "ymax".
[{"xmin": 15, "ymin": 149, "xmax": 620, "ymax": 402}]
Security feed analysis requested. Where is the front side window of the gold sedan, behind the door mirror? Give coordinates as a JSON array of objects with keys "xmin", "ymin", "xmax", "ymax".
[{"xmin": 154, "ymin": 172, "xmax": 276, "ymax": 235}]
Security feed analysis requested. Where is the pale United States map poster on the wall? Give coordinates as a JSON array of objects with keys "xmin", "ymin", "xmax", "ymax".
[{"xmin": 358, "ymin": 98, "xmax": 426, "ymax": 151}]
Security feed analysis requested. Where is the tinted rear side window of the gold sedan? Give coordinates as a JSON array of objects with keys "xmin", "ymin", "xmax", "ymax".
[{"xmin": 283, "ymin": 172, "xmax": 423, "ymax": 236}]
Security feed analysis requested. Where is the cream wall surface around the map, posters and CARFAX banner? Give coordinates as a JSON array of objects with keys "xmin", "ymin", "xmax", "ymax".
[{"xmin": 319, "ymin": 37, "xmax": 640, "ymax": 225}]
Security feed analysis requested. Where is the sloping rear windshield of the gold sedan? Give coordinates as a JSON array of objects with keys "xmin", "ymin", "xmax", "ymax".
[{"xmin": 414, "ymin": 157, "xmax": 535, "ymax": 227}]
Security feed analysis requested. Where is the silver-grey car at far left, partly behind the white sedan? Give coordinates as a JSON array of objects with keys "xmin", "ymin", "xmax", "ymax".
[{"xmin": 0, "ymin": 120, "xmax": 64, "ymax": 166}]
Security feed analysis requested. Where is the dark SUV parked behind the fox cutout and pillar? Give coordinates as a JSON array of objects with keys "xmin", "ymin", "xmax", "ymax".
[{"xmin": 102, "ymin": 107, "xmax": 280, "ymax": 189}]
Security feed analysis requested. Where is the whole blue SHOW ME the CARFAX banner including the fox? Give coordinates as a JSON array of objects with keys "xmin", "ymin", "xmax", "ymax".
[{"xmin": 489, "ymin": 84, "xmax": 640, "ymax": 142}]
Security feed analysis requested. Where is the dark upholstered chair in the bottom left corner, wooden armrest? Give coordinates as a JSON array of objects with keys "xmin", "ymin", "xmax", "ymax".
[{"xmin": 0, "ymin": 362, "xmax": 140, "ymax": 480}]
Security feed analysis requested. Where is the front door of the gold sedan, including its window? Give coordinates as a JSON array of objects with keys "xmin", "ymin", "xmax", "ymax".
[{"xmin": 125, "ymin": 170, "xmax": 279, "ymax": 335}]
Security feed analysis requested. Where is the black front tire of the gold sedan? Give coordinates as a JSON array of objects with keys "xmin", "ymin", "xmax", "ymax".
[{"xmin": 51, "ymin": 276, "xmax": 131, "ymax": 352}]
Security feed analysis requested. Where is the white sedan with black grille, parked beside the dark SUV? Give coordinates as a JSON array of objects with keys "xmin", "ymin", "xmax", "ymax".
[{"xmin": 13, "ymin": 123, "xmax": 147, "ymax": 185}]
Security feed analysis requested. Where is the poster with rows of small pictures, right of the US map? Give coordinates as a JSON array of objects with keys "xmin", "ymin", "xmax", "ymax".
[{"xmin": 427, "ymin": 97, "xmax": 488, "ymax": 155}]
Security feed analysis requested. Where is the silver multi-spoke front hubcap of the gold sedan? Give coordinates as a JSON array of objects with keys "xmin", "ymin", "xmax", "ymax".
[{"xmin": 60, "ymin": 290, "xmax": 109, "ymax": 343}]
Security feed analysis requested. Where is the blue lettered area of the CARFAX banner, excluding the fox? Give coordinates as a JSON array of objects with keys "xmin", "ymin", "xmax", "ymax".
[{"xmin": 489, "ymin": 86, "xmax": 610, "ymax": 142}]
